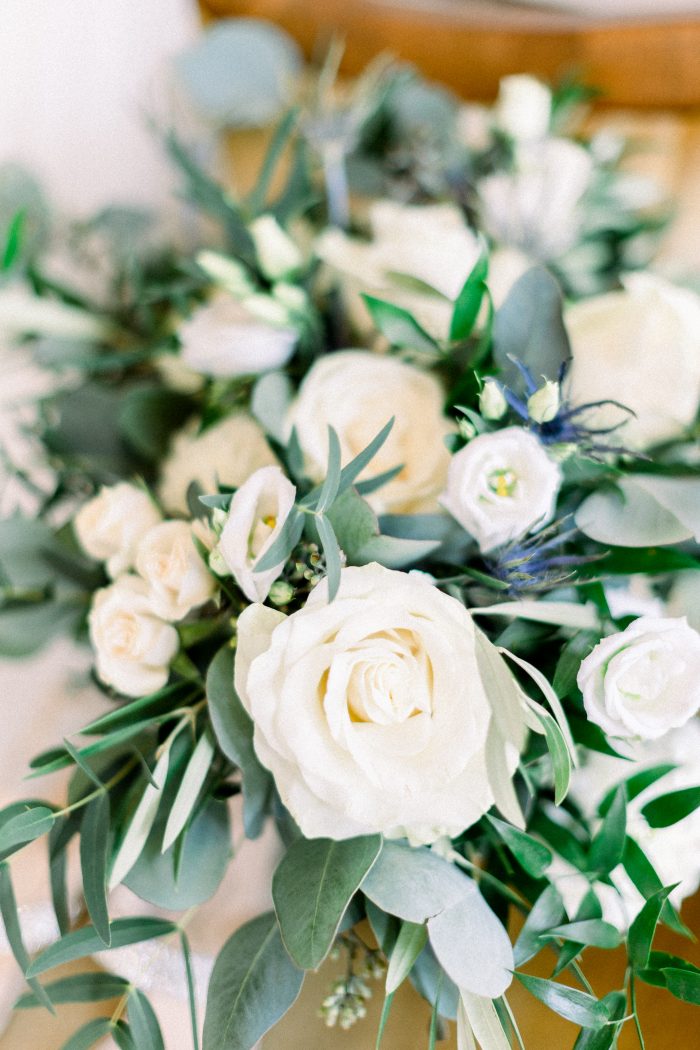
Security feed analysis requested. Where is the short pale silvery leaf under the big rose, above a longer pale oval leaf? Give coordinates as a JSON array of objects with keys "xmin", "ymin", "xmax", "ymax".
[{"xmin": 362, "ymin": 841, "xmax": 472, "ymax": 923}]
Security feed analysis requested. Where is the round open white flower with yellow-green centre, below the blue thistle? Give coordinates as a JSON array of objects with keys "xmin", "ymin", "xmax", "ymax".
[{"xmin": 440, "ymin": 426, "xmax": 561, "ymax": 551}]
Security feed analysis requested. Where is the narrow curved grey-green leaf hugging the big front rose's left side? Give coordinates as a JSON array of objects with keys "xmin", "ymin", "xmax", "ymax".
[{"xmin": 207, "ymin": 646, "xmax": 274, "ymax": 839}]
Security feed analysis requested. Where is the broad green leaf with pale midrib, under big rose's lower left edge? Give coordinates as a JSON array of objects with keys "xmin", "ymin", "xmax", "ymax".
[{"xmin": 272, "ymin": 835, "xmax": 382, "ymax": 970}]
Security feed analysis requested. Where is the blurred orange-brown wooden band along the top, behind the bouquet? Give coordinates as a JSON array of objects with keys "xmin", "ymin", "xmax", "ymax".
[{"xmin": 201, "ymin": 0, "xmax": 700, "ymax": 106}]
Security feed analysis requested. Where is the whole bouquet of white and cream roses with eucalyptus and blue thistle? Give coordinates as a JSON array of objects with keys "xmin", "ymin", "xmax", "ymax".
[{"xmin": 0, "ymin": 38, "xmax": 700, "ymax": 1050}]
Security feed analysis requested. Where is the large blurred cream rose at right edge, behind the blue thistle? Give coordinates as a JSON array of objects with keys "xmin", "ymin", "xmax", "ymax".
[{"xmin": 566, "ymin": 273, "xmax": 700, "ymax": 449}]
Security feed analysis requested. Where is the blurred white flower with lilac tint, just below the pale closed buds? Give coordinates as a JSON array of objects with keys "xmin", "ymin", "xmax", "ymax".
[{"xmin": 177, "ymin": 292, "xmax": 298, "ymax": 378}]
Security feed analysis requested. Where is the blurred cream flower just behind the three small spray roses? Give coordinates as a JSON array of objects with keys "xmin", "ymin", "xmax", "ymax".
[{"xmin": 158, "ymin": 412, "xmax": 276, "ymax": 513}]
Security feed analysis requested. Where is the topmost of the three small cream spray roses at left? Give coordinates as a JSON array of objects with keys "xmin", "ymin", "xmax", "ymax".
[{"xmin": 73, "ymin": 481, "xmax": 161, "ymax": 579}]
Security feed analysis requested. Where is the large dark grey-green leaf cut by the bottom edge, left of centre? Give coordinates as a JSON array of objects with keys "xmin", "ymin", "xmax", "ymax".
[{"xmin": 203, "ymin": 911, "xmax": 303, "ymax": 1050}]
